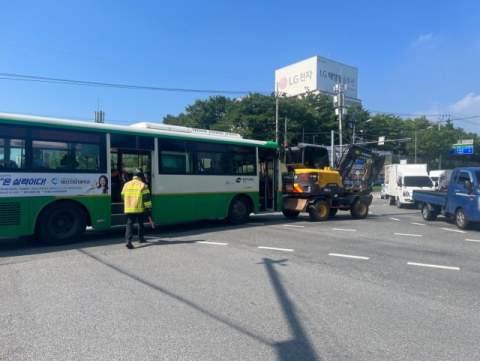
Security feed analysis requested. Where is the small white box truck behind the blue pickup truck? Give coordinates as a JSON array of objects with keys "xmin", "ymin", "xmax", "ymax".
[{"xmin": 385, "ymin": 164, "xmax": 435, "ymax": 208}]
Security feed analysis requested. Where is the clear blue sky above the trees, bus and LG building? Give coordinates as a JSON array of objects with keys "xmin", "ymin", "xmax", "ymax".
[{"xmin": 0, "ymin": 0, "xmax": 480, "ymax": 133}]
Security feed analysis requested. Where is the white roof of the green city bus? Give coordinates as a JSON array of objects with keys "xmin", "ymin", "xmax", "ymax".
[{"xmin": 0, "ymin": 113, "xmax": 278, "ymax": 148}]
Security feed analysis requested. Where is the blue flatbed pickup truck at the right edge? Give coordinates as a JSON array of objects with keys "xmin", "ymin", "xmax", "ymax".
[{"xmin": 413, "ymin": 167, "xmax": 480, "ymax": 229}]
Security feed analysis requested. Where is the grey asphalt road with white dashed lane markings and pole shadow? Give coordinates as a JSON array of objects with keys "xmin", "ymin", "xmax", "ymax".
[{"xmin": 0, "ymin": 199, "xmax": 480, "ymax": 361}]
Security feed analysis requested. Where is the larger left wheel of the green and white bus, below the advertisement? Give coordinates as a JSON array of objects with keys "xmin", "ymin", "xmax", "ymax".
[{"xmin": 37, "ymin": 202, "xmax": 87, "ymax": 245}]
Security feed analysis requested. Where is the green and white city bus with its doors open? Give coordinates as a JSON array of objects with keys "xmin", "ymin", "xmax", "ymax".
[{"xmin": 0, "ymin": 113, "xmax": 282, "ymax": 244}]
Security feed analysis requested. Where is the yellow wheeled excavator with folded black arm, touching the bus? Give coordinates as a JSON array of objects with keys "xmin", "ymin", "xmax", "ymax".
[{"xmin": 282, "ymin": 144, "xmax": 385, "ymax": 221}]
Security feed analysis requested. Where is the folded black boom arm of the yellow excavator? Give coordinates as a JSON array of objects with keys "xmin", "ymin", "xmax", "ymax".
[{"xmin": 337, "ymin": 144, "xmax": 385, "ymax": 195}]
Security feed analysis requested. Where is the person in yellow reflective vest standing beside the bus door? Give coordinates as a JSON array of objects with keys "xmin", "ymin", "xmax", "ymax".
[{"xmin": 122, "ymin": 168, "xmax": 152, "ymax": 249}]
